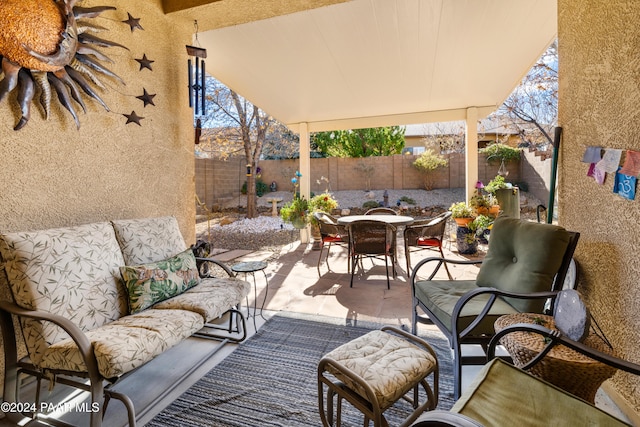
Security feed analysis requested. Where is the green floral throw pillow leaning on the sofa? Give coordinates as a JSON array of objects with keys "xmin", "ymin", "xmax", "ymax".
[{"xmin": 120, "ymin": 249, "xmax": 200, "ymax": 314}]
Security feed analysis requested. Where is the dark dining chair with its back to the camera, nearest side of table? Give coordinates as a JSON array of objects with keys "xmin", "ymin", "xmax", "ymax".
[{"xmin": 347, "ymin": 220, "xmax": 397, "ymax": 289}]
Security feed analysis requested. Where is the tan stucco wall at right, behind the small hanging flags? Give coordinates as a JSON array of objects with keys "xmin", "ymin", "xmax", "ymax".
[{"xmin": 558, "ymin": 0, "xmax": 640, "ymax": 414}]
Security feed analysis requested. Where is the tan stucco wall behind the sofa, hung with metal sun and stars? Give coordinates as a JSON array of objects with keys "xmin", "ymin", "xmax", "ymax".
[{"xmin": 0, "ymin": 0, "xmax": 195, "ymax": 242}]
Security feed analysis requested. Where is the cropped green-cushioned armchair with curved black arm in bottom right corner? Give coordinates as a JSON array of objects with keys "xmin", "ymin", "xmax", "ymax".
[{"xmin": 411, "ymin": 324, "xmax": 640, "ymax": 427}]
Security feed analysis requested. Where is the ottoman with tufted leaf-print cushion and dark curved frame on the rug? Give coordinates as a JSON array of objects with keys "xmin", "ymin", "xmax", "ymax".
[{"xmin": 318, "ymin": 326, "xmax": 438, "ymax": 427}]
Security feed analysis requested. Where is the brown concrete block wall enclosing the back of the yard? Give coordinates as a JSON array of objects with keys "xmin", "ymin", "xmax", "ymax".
[{"xmin": 195, "ymin": 152, "xmax": 551, "ymax": 207}]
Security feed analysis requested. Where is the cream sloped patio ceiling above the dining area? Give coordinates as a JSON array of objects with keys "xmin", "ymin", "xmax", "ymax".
[{"xmin": 198, "ymin": 0, "xmax": 557, "ymax": 132}]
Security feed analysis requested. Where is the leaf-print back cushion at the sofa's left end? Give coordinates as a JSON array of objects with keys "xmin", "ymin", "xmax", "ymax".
[{"xmin": 0, "ymin": 222, "xmax": 127, "ymax": 364}]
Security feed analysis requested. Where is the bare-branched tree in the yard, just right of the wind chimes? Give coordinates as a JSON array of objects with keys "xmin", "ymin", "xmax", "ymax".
[{"xmin": 202, "ymin": 77, "xmax": 274, "ymax": 218}]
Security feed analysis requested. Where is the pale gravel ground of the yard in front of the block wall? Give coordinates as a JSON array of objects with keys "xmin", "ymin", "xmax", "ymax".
[{"xmin": 196, "ymin": 188, "xmax": 540, "ymax": 253}]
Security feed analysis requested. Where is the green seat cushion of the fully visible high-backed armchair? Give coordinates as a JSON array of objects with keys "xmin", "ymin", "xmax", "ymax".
[{"xmin": 415, "ymin": 280, "xmax": 518, "ymax": 335}]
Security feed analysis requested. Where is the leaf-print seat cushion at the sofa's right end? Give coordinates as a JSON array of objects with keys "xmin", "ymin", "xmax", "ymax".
[{"xmin": 153, "ymin": 277, "xmax": 251, "ymax": 322}]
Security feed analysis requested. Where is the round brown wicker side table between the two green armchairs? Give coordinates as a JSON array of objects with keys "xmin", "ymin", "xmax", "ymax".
[{"xmin": 494, "ymin": 313, "xmax": 616, "ymax": 403}]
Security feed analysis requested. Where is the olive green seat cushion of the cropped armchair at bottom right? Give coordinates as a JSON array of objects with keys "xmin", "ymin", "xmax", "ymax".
[{"xmin": 451, "ymin": 359, "xmax": 627, "ymax": 427}]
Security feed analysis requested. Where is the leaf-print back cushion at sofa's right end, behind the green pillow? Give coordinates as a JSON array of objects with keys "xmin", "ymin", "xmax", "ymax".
[{"xmin": 111, "ymin": 216, "xmax": 187, "ymax": 265}]
